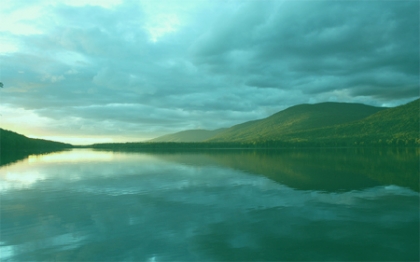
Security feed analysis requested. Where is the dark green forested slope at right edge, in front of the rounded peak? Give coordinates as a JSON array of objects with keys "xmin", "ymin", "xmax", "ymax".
[{"xmin": 283, "ymin": 99, "xmax": 420, "ymax": 145}]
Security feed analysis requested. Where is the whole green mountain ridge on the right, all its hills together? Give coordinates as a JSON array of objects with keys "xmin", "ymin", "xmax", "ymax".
[{"xmin": 146, "ymin": 99, "xmax": 420, "ymax": 146}]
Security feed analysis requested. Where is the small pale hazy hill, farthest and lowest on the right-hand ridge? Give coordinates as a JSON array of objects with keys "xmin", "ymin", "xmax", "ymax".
[{"xmin": 148, "ymin": 128, "xmax": 225, "ymax": 142}]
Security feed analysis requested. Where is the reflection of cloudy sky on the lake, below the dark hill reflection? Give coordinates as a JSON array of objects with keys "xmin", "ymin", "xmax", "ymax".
[{"xmin": 1, "ymin": 148, "xmax": 419, "ymax": 261}]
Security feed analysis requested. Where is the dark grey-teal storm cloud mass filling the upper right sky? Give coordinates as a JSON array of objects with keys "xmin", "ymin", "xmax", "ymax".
[{"xmin": 192, "ymin": 1, "xmax": 419, "ymax": 99}]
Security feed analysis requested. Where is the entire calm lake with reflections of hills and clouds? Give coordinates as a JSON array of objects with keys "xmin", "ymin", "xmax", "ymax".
[{"xmin": 0, "ymin": 148, "xmax": 419, "ymax": 261}]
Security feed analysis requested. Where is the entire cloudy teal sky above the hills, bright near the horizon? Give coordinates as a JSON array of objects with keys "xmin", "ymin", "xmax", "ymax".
[{"xmin": 0, "ymin": 0, "xmax": 419, "ymax": 144}]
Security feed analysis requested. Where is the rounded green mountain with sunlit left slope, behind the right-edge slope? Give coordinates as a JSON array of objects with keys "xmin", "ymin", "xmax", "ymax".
[{"xmin": 207, "ymin": 102, "xmax": 385, "ymax": 142}]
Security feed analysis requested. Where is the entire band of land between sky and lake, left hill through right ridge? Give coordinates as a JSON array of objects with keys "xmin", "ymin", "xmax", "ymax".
[{"xmin": 0, "ymin": 99, "xmax": 420, "ymax": 151}]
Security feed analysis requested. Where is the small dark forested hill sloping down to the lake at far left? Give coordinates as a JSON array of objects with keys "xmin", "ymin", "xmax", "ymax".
[{"xmin": 0, "ymin": 128, "xmax": 73, "ymax": 151}]
